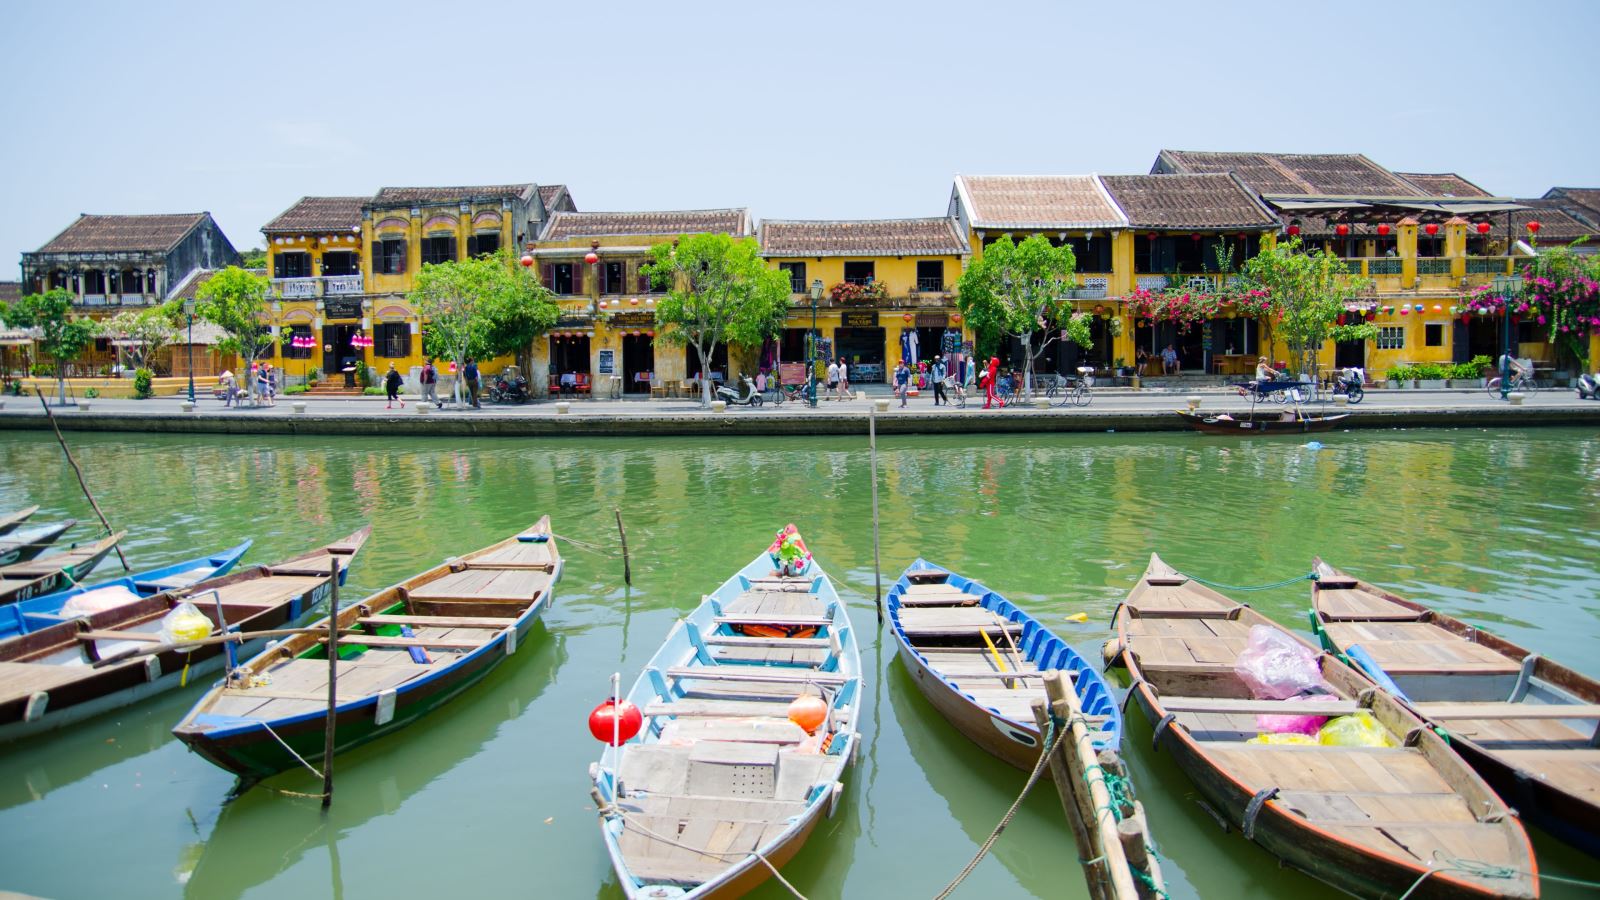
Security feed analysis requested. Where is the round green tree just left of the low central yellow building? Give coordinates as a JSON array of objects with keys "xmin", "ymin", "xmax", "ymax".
[{"xmin": 643, "ymin": 234, "xmax": 789, "ymax": 407}]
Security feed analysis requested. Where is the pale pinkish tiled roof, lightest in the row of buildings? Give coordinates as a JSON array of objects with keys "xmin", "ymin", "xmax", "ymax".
[{"xmin": 955, "ymin": 175, "xmax": 1128, "ymax": 227}]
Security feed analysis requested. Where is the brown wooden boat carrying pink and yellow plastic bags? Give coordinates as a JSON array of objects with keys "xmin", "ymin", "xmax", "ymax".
[{"xmin": 1117, "ymin": 554, "xmax": 1539, "ymax": 898}]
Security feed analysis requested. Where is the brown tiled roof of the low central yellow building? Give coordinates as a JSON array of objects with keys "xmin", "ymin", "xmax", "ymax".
[{"xmin": 762, "ymin": 218, "xmax": 968, "ymax": 256}]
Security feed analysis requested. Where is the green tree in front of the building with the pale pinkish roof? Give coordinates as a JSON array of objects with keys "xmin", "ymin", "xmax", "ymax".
[{"xmin": 955, "ymin": 234, "xmax": 1093, "ymax": 392}]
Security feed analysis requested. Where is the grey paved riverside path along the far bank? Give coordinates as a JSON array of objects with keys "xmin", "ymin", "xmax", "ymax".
[{"xmin": 0, "ymin": 386, "xmax": 1600, "ymax": 436}]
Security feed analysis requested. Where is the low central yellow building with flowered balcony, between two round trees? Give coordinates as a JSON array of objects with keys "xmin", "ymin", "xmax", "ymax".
[{"xmin": 760, "ymin": 218, "xmax": 971, "ymax": 384}]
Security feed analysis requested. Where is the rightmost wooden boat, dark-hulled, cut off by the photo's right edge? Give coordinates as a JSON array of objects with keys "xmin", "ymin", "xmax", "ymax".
[{"xmin": 1312, "ymin": 559, "xmax": 1600, "ymax": 855}]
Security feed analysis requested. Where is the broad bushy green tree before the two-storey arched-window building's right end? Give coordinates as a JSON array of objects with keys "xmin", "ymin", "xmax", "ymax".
[{"xmin": 410, "ymin": 248, "xmax": 560, "ymax": 404}]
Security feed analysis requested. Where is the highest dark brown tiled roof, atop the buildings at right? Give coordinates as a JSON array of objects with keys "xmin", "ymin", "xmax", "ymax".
[{"xmin": 1155, "ymin": 151, "xmax": 1416, "ymax": 197}]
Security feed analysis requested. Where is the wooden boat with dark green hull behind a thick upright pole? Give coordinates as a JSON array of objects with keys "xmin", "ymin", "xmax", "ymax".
[{"xmin": 173, "ymin": 516, "xmax": 562, "ymax": 781}]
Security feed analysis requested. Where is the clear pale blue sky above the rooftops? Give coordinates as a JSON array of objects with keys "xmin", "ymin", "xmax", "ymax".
[{"xmin": 0, "ymin": 0, "xmax": 1600, "ymax": 267}]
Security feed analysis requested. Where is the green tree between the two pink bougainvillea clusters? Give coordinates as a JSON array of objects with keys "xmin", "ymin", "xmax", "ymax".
[{"xmin": 1243, "ymin": 237, "xmax": 1368, "ymax": 376}]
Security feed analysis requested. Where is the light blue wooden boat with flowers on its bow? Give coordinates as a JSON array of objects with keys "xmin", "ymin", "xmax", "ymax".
[{"xmin": 589, "ymin": 525, "xmax": 861, "ymax": 898}]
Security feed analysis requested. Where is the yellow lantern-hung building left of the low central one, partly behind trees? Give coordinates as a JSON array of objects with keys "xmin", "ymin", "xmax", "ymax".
[{"xmin": 525, "ymin": 208, "xmax": 750, "ymax": 396}]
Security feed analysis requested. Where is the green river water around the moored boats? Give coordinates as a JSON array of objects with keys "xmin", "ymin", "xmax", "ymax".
[{"xmin": 0, "ymin": 429, "xmax": 1600, "ymax": 898}]
